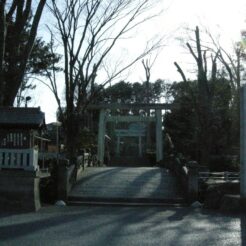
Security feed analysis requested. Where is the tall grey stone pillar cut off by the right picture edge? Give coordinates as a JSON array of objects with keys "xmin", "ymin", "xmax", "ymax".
[{"xmin": 240, "ymin": 85, "xmax": 246, "ymax": 199}]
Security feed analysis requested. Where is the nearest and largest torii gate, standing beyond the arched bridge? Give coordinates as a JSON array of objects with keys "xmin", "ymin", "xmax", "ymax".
[{"xmin": 89, "ymin": 103, "xmax": 171, "ymax": 164}]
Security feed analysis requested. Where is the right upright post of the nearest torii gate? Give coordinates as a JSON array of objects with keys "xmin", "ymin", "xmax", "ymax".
[{"xmin": 155, "ymin": 109, "xmax": 163, "ymax": 162}]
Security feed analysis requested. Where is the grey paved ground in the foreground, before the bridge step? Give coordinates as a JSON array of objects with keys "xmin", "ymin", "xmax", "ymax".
[{"xmin": 0, "ymin": 206, "xmax": 246, "ymax": 246}]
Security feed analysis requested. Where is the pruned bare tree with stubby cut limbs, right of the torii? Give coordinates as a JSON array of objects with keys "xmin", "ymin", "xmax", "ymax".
[{"xmin": 174, "ymin": 27, "xmax": 218, "ymax": 165}]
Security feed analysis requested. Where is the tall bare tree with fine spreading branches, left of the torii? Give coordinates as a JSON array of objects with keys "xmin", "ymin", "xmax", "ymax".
[{"xmin": 46, "ymin": 0, "xmax": 164, "ymax": 160}]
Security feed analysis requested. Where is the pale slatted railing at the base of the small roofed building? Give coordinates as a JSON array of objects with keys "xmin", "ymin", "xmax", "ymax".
[{"xmin": 0, "ymin": 149, "xmax": 39, "ymax": 171}]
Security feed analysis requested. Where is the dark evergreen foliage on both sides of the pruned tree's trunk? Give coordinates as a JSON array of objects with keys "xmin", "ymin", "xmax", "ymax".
[{"xmin": 164, "ymin": 78, "xmax": 234, "ymax": 168}]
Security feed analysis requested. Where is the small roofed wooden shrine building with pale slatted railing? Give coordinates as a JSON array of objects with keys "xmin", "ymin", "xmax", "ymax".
[{"xmin": 0, "ymin": 107, "xmax": 45, "ymax": 171}]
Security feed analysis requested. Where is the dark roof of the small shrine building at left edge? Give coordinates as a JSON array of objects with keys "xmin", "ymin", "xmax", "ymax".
[{"xmin": 0, "ymin": 107, "xmax": 45, "ymax": 128}]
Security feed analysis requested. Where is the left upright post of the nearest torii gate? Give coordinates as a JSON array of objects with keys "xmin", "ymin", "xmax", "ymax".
[{"xmin": 97, "ymin": 109, "xmax": 106, "ymax": 165}]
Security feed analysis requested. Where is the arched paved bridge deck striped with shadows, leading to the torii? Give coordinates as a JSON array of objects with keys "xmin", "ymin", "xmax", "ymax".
[{"xmin": 69, "ymin": 167, "xmax": 182, "ymax": 202}]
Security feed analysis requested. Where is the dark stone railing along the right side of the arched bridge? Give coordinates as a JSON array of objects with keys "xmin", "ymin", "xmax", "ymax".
[{"xmin": 172, "ymin": 157, "xmax": 198, "ymax": 202}]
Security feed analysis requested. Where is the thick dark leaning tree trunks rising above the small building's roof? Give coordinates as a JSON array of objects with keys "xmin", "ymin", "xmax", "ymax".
[{"xmin": 0, "ymin": 0, "xmax": 46, "ymax": 106}]
